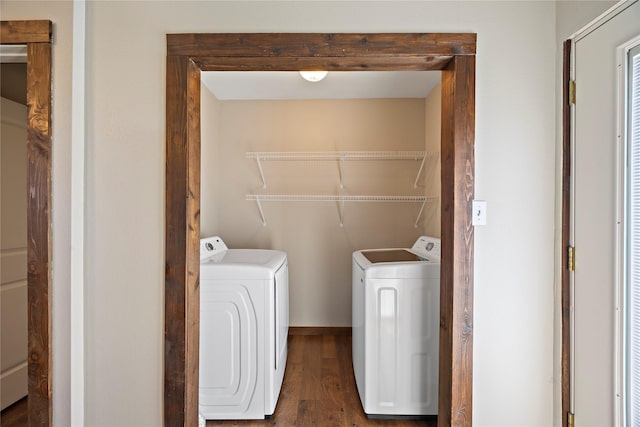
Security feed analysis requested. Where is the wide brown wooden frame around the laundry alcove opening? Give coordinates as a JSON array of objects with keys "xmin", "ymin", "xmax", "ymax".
[{"xmin": 164, "ymin": 33, "xmax": 476, "ymax": 426}]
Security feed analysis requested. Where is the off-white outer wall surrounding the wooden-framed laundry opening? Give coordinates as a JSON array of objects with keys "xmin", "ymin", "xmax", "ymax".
[{"xmin": 2, "ymin": 1, "xmax": 616, "ymax": 426}]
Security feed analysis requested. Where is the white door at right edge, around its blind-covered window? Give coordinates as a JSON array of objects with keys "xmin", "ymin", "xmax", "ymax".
[{"xmin": 571, "ymin": 1, "xmax": 640, "ymax": 427}]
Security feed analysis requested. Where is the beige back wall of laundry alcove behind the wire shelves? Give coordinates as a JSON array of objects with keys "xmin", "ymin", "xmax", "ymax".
[{"xmin": 201, "ymin": 99, "xmax": 430, "ymax": 326}]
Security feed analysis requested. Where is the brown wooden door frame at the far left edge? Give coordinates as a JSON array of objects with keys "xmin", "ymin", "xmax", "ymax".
[{"xmin": 0, "ymin": 20, "xmax": 53, "ymax": 427}]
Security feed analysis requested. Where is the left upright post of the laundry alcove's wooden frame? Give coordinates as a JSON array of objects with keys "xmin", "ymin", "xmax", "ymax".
[{"xmin": 164, "ymin": 56, "xmax": 200, "ymax": 426}]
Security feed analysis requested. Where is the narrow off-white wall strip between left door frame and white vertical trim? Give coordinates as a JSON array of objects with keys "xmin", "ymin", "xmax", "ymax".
[{"xmin": 0, "ymin": 0, "xmax": 73, "ymax": 426}]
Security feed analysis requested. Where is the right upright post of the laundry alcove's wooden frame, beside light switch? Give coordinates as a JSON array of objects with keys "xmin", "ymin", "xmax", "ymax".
[{"xmin": 438, "ymin": 56, "xmax": 475, "ymax": 426}]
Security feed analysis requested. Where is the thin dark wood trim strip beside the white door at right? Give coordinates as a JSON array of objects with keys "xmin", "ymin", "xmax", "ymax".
[{"xmin": 560, "ymin": 40, "xmax": 572, "ymax": 427}]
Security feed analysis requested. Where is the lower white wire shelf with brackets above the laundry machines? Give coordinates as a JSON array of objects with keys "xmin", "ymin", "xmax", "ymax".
[{"xmin": 246, "ymin": 194, "xmax": 438, "ymax": 228}]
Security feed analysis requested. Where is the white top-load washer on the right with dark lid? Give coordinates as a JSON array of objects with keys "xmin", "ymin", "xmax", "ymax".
[{"xmin": 352, "ymin": 236, "xmax": 440, "ymax": 418}]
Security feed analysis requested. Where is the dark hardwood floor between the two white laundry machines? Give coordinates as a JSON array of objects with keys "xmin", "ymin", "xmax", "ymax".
[{"xmin": 207, "ymin": 335, "xmax": 437, "ymax": 427}]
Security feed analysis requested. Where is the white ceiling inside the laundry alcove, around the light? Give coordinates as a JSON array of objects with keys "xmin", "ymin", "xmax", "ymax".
[{"xmin": 201, "ymin": 71, "xmax": 440, "ymax": 101}]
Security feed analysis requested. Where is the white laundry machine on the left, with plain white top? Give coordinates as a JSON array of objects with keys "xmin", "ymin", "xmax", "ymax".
[{"xmin": 199, "ymin": 237, "xmax": 289, "ymax": 420}]
